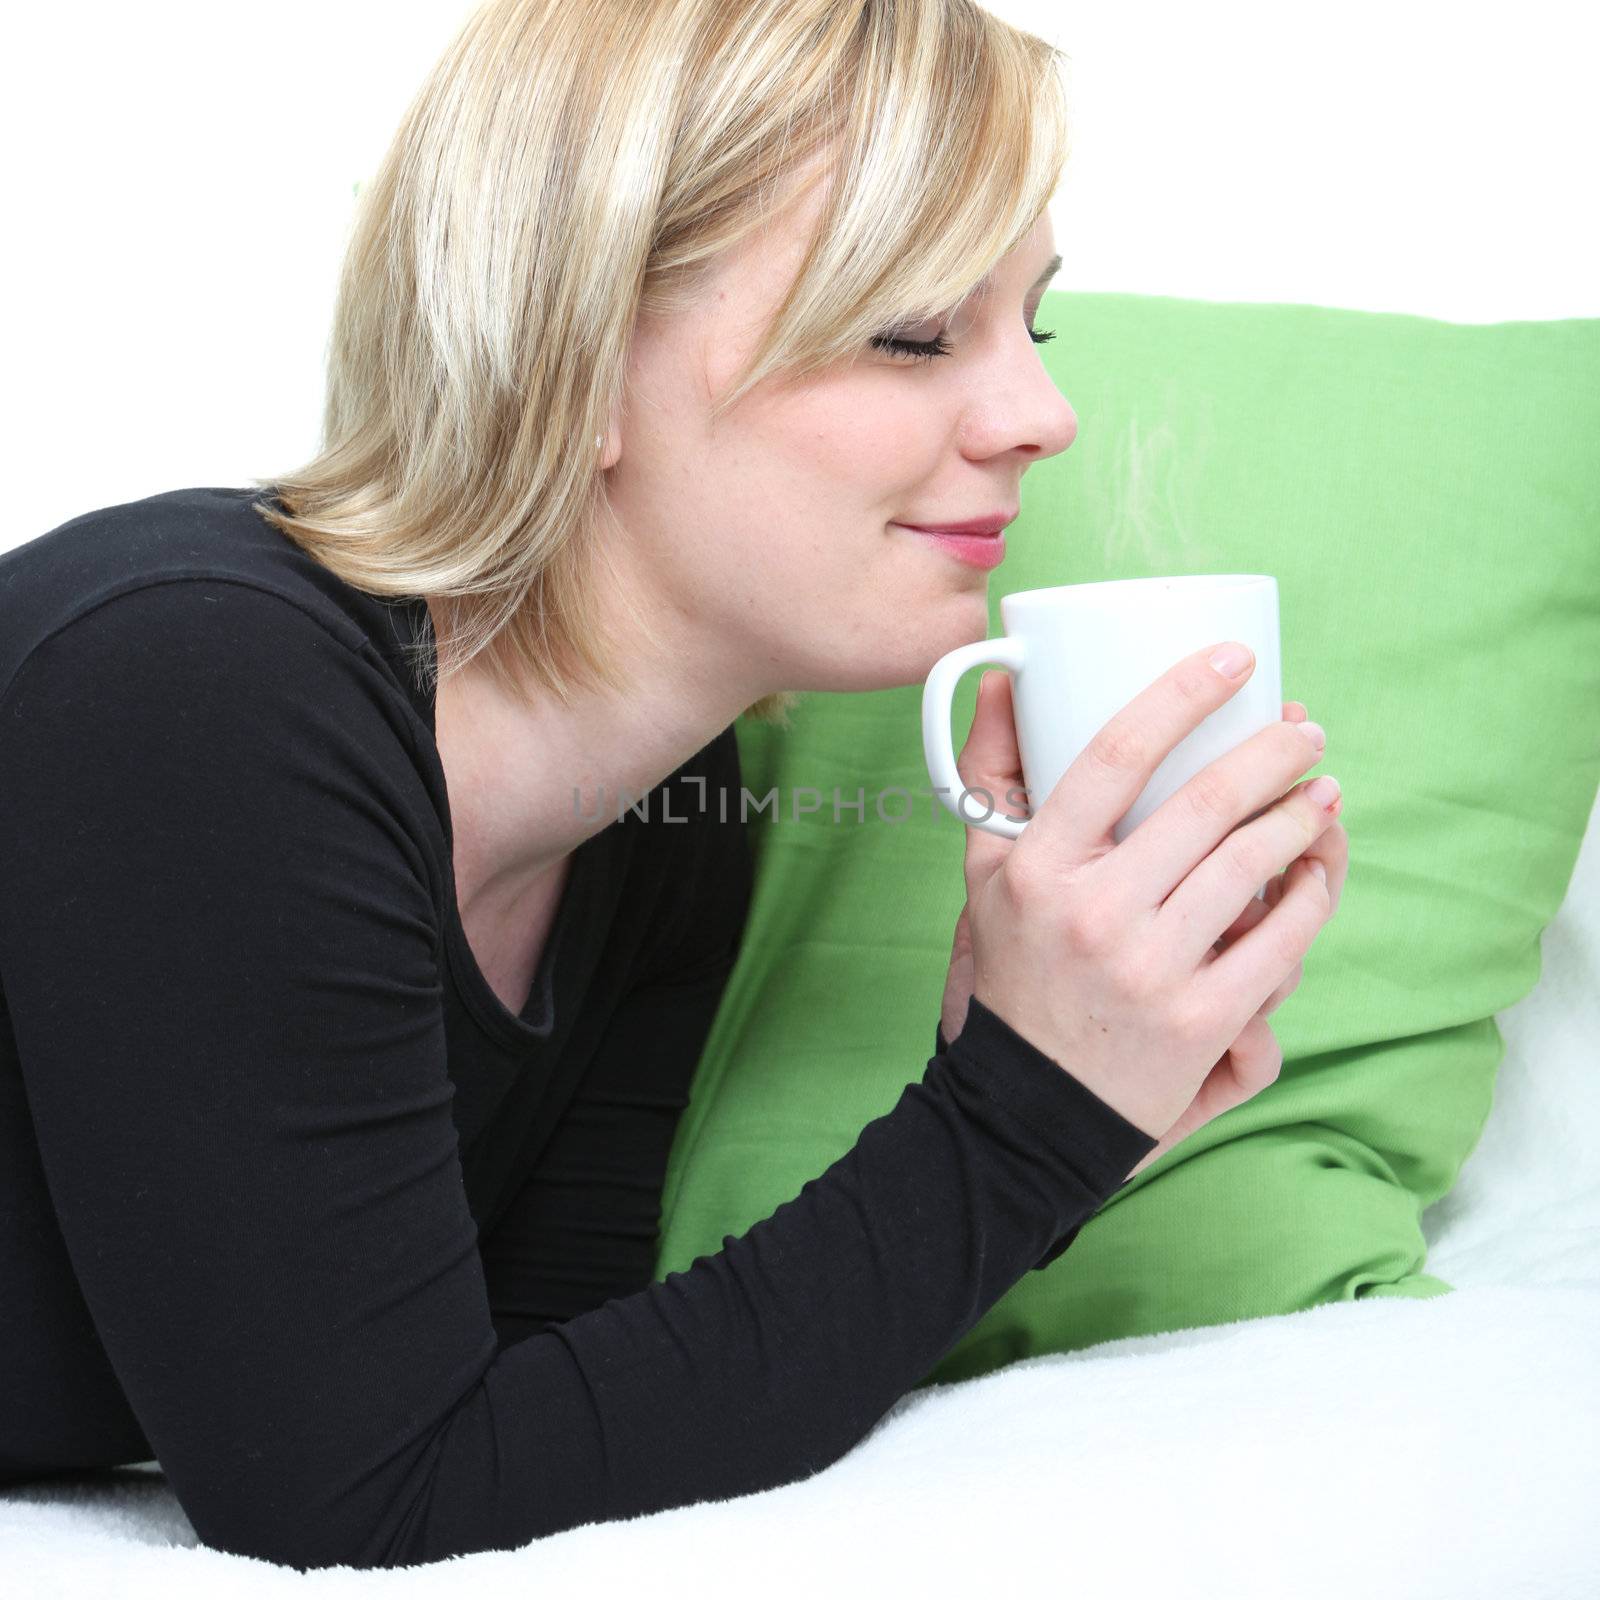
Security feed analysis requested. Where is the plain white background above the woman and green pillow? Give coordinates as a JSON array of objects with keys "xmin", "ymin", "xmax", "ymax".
[{"xmin": 0, "ymin": 0, "xmax": 1600, "ymax": 549}]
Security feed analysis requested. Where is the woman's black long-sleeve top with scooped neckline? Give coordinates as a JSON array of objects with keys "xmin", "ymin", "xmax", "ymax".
[{"xmin": 0, "ymin": 488, "xmax": 1155, "ymax": 1568}]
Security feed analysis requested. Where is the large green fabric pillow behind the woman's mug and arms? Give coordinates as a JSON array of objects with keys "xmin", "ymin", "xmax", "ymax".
[{"xmin": 658, "ymin": 291, "xmax": 1600, "ymax": 1387}]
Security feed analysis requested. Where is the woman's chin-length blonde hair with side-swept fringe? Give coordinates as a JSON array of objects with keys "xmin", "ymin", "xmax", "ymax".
[{"xmin": 254, "ymin": 0, "xmax": 1069, "ymax": 725}]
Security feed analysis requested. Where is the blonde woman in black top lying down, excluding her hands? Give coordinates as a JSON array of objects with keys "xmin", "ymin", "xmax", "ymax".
[{"xmin": 0, "ymin": 0, "xmax": 1344, "ymax": 1566}]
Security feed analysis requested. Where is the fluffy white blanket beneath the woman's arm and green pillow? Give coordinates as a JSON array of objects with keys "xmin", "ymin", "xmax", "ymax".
[{"xmin": 0, "ymin": 1283, "xmax": 1600, "ymax": 1600}]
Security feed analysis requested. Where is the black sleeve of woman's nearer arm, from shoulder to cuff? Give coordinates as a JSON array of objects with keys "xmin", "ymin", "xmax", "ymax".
[{"xmin": 0, "ymin": 582, "xmax": 1154, "ymax": 1568}]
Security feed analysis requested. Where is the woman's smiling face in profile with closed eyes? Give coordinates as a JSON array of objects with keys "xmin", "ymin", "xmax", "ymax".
[{"xmin": 602, "ymin": 172, "xmax": 1077, "ymax": 715}]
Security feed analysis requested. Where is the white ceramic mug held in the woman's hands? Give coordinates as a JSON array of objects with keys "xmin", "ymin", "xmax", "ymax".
[{"xmin": 922, "ymin": 573, "xmax": 1283, "ymax": 898}]
